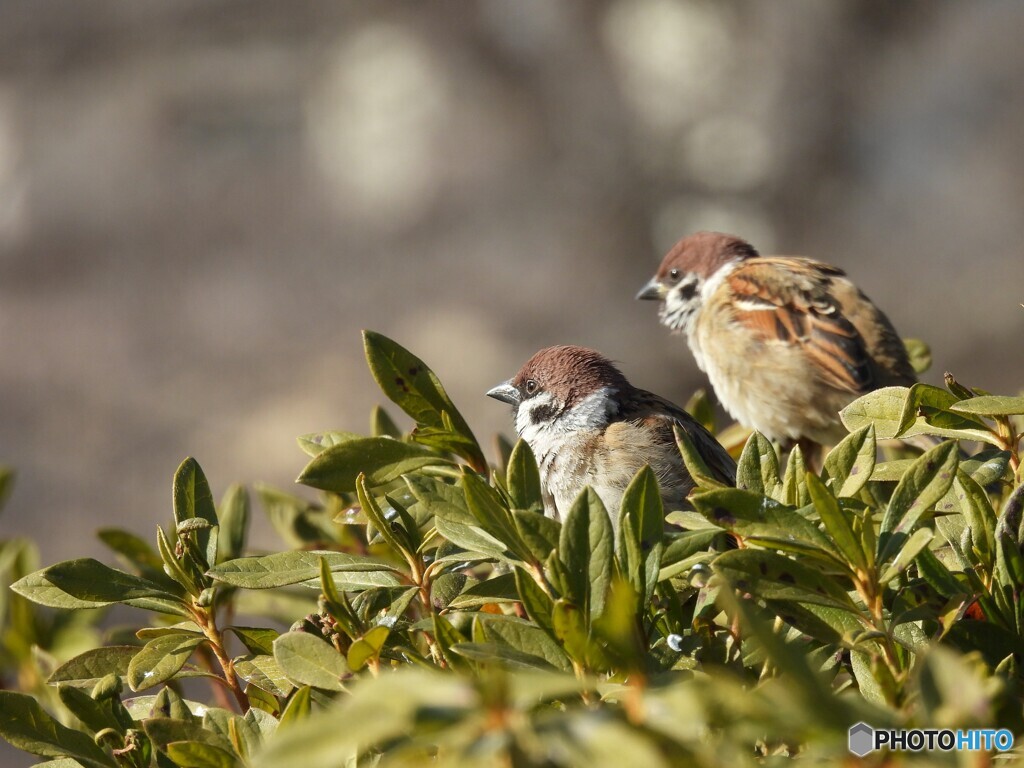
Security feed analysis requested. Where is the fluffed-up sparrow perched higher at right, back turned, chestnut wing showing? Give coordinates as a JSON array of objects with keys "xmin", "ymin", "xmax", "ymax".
[{"xmin": 637, "ymin": 231, "xmax": 916, "ymax": 455}]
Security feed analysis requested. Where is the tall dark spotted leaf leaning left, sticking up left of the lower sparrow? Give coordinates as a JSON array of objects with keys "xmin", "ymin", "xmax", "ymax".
[{"xmin": 362, "ymin": 331, "xmax": 487, "ymax": 470}]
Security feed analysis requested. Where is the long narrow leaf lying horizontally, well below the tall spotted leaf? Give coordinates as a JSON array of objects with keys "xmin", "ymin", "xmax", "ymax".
[{"xmin": 209, "ymin": 550, "xmax": 401, "ymax": 590}]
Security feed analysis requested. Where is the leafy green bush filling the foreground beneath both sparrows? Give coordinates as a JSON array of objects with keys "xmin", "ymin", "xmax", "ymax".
[{"xmin": 0, "ymin": 333, "xmax": 1024, "ymax": 768}]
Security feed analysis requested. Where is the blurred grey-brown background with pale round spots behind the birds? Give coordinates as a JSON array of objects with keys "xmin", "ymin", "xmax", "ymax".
[{"xmin": 0, "ymin": 0, "xmax": 1024, "ymax": 563}]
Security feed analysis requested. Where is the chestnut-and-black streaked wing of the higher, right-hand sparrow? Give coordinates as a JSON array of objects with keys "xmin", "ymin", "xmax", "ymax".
[{"xmin": 726, "ymin": 256, "xmax": 874, "ymax": 394}]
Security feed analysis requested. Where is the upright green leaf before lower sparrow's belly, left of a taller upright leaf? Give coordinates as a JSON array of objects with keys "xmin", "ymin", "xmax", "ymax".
[{"xmin": 558, "ymin": 485, "xmax": 614, "ymax": 627}]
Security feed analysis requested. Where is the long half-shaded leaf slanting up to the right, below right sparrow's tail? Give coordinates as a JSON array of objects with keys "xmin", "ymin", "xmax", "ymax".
[{"xmin": 878, "ymin": 440, "xmax": 958, "ymax": 563}]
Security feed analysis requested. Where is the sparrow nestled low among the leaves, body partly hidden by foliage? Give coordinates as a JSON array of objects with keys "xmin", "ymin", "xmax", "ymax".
[{"xmin": 487, "ymin": 346, "xmax": 736, "ymax": 521}]
